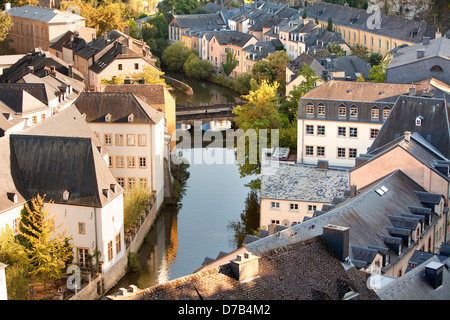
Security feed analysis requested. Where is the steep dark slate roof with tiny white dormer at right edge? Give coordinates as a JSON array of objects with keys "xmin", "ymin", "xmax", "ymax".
[{"xmin": 369, "ymin": 95, "xmax": 450, "ymax": 158}]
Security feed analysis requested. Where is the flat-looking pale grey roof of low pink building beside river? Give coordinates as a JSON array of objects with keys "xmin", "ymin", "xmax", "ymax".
[{"xmin": 261, "ymin": 163, "xmax": 349, "ymax": 203}]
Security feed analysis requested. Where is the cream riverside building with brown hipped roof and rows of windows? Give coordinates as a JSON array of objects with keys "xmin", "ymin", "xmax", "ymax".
[{"xmin": 74, "ymin": 92, "xmax": 164, "ymax": 207}]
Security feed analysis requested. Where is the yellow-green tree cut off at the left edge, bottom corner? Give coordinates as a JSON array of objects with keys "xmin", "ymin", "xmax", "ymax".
[{"xmin": 0, "ymin": 225, "xmax": 29, "ymax": 300}]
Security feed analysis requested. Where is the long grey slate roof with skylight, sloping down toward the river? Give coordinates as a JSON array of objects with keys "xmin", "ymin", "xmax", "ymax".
[{"xmin": 246, "ymin": 170, "xmax": 437, "ymax": 270}]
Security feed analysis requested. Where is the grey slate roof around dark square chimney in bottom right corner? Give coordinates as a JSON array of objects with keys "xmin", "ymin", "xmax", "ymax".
[{"xmin": 377, "ymin": 257, "xmax": 450, "ymax": 300}]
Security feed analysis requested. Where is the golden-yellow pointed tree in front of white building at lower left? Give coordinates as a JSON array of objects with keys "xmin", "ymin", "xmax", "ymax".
[{"xmin": 20, "ymin": 195, "xmax": 72, "ymax": 288}]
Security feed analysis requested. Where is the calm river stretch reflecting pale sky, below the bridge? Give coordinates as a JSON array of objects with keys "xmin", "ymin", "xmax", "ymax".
[{"xmin": 110, "ymin": 148, "xmax": 259, "ymax": 294}]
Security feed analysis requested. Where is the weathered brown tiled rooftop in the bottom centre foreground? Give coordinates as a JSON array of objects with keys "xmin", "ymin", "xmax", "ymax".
[{"xmin": 111, "ymin": 237, "xmax": 377, "ymax": 300}]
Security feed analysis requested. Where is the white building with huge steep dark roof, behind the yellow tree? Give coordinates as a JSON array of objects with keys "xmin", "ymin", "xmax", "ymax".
[{"xmin": 0, "ymin": 107, "xmax": 125, "ymax": 272}]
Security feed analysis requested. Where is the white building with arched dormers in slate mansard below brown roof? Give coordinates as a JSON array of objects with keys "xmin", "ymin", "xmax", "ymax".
[{"xmin": 297, "ymin": 80, "xmax": 428, "ymax": 167}]
